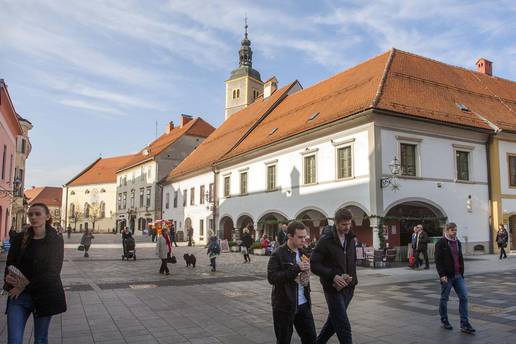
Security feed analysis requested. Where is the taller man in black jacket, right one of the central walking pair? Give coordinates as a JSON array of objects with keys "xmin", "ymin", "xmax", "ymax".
[{"xmin": 310, "ymin": 208, "xmax": 357, "ymax": 344}]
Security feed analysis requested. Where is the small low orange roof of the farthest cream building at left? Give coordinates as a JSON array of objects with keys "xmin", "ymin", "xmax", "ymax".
[{"xmin": 66, "ymin": 154, "xmax": 134, "ymax": 186}]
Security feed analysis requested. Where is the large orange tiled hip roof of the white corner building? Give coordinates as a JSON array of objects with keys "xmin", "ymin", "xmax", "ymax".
[{"xmin": 219, "ymin": 49, "xmax": 516, "ymax": 161}]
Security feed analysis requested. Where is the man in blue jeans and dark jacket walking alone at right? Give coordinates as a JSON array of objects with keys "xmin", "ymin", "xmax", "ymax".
[{"xmin": 435, "ymin": 222, "xmax": 475, "ymax": 334}]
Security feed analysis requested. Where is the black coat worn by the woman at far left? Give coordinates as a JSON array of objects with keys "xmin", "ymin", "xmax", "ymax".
[{"xmin": 4, "ymin": 226, "xmax": 66, "ymax": 317}]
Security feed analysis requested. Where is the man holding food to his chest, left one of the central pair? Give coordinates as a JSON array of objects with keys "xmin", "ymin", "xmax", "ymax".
[{"xmin": 267, "ymin": 221, "xmax": 316, "ymax": 344}]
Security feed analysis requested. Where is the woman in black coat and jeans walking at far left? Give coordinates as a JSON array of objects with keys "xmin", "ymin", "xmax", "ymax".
[{"xmin": 4, "ymin": 203, "xmax": 66, "ymax": 344}]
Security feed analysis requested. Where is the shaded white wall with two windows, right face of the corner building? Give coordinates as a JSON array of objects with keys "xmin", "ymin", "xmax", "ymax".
[{"xmin": 381, "ymin": 129, "xmax": 489, "ymax": 242}]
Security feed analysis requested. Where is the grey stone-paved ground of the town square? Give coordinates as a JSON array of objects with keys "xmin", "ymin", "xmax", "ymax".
[{"xmin": 0, "ymin": 246, "xmax": 516, "ymax": 344}]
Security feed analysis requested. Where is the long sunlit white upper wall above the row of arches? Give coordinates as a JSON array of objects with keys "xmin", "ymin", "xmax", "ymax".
[{"xmin": 217, "ymin": 124, "xmax": 371, "ymax": 226}]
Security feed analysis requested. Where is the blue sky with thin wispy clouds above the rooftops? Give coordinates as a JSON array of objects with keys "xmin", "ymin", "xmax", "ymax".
[{"xmin": 0, "ymin": 0, "xmax": 516, "ymax": 187}]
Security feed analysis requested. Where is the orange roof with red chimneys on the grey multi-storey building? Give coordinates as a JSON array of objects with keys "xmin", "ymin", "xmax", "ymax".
[{"xmin": 117, "ymin": 117, "xmax": 215, "ymax": 172}]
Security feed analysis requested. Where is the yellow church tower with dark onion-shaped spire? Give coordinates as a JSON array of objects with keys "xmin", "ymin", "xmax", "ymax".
[{"xmin": 225, "ymin": 18, "xmax": 263, "ymax": 119}]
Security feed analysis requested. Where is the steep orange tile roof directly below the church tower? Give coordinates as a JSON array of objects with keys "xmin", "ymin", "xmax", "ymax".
[{"xmin": 165, "ymin": 81, "xmax": 297, "ymax": 182}]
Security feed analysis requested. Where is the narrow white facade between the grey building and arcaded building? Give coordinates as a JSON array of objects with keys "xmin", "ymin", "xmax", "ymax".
[{"xmin": 162, "ymin": 172, "xmax": 214, "ymax": 243}]
